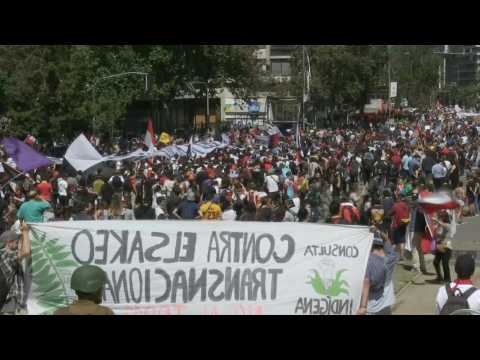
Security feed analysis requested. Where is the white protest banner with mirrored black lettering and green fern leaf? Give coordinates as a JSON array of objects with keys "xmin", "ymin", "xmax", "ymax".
[{"xmin": 28, "ymin": 221, "xmax": 373, "ymax": 315}]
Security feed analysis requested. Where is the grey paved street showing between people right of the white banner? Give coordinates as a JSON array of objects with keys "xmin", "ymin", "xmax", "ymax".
[{"xmin": 394, "ymin": 217, "xmax": 480, "ymax": 315}]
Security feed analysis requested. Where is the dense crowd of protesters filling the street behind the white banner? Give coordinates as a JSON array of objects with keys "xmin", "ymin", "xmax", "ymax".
[{"xmin": 0, "ymin": 108, "xmax": 480, "ymax": 316}]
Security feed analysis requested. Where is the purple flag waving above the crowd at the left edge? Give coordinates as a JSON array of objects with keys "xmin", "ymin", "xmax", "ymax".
[{"xmin": 2, "ymin": 138, "xmax": 53, "ymax": 172}]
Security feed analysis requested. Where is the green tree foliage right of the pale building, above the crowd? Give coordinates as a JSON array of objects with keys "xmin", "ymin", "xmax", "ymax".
[{"xmin": 291, "ymin": 45, "xmax": 440, "ymax": 118}]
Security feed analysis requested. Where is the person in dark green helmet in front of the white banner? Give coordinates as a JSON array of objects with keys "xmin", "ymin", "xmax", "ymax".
[{"xmin": 54, "ymin": 265, "xmax": 114, "ymax": 315}]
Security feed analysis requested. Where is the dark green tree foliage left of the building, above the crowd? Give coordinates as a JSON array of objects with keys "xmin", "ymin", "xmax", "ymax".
[{"xmin": 0, "ymin": 45, "xmax": 258, "ymax": 138}]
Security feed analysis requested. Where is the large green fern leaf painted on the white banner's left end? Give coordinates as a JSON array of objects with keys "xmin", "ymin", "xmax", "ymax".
[{"xmin": 32, "ymin": 231, "xmax": 79, "ymax": 314}]
